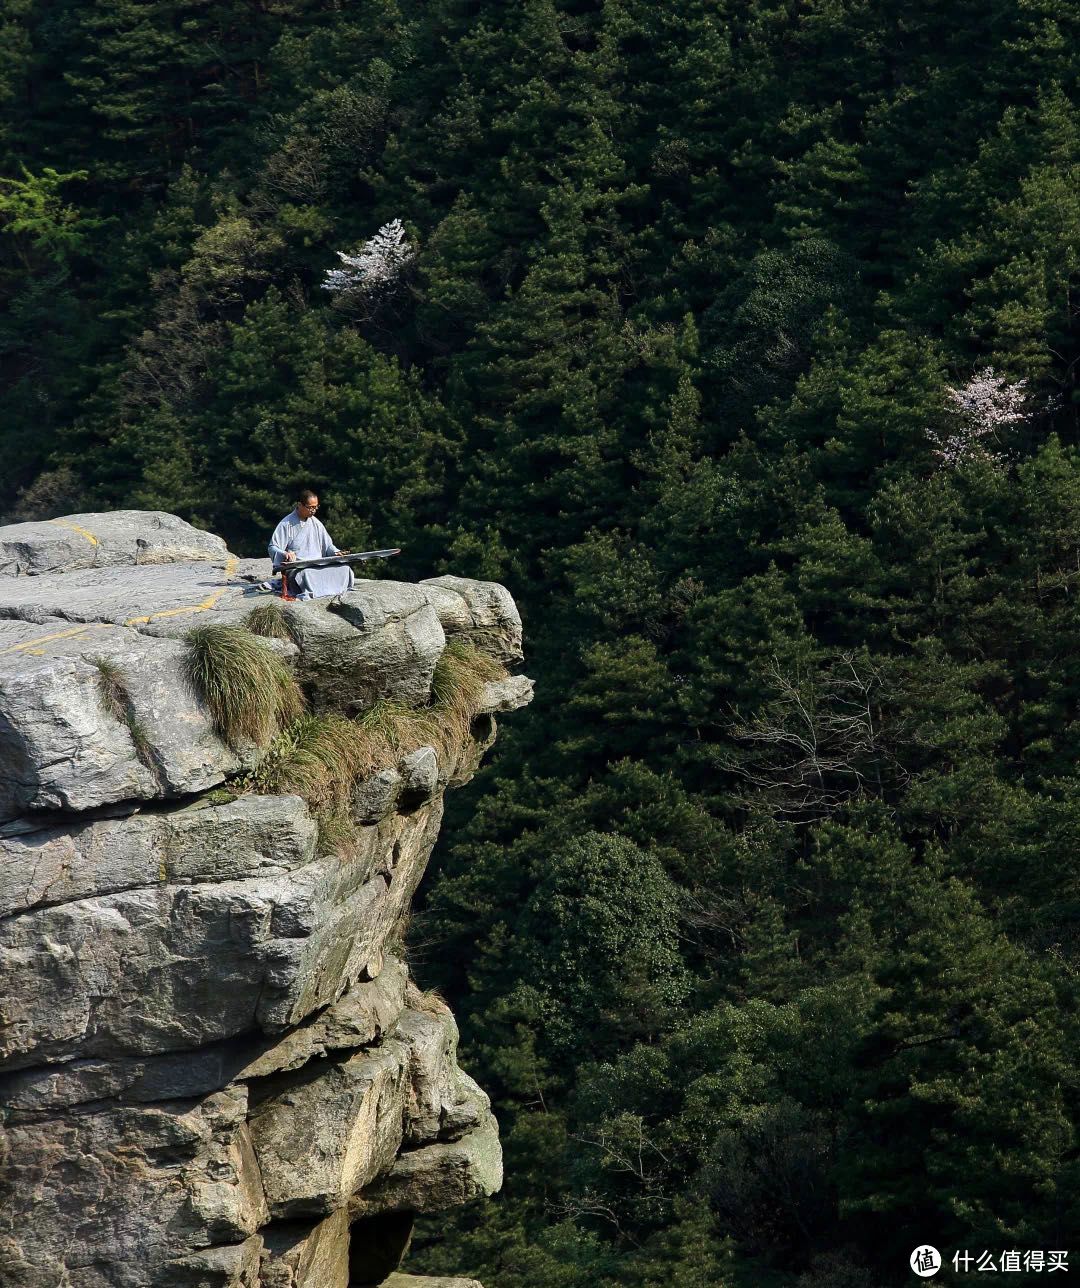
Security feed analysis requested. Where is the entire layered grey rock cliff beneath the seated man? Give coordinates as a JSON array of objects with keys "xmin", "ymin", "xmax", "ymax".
[{"xmin": 0, "ymin": 511, "xmax": 532, "ymax": 1288}]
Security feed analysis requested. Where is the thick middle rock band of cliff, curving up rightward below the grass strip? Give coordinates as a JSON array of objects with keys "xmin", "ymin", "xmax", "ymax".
[{"xmin": 0, "ymin": 797, "xmax": 440, "ymax": 1069}]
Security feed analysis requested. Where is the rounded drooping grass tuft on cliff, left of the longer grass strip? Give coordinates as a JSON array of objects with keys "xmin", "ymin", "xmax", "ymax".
[{"xmin": 184, "ymin": 626, "xmax": 304, "ymax": 747}]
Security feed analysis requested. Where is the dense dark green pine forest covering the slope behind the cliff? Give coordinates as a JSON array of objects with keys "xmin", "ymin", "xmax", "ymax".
[{"xmin": 0, "ymin": 0, "xmax": 1080, "ymax": 1288}]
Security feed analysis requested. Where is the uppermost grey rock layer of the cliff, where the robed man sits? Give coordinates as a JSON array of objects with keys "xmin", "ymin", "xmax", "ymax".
[{"xmin": 0, "ymin": 530, "xmax": 530, "ymax": 823}]
